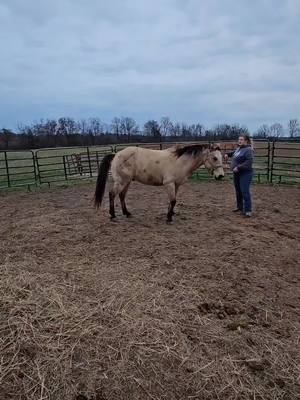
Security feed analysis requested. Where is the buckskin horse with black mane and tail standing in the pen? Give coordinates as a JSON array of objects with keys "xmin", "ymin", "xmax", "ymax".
[{"xmin": 95, "ymin": 144, "xmax": 224, "ymax": 222}]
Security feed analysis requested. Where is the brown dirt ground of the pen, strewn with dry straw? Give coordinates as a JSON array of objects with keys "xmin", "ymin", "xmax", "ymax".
[{"xmin": 0, "ymin": 182, "xmax": 300, "ymax": 400}]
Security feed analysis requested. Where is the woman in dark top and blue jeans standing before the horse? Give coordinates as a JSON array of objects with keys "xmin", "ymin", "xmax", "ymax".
[{"xmin": 225, "ymin": 135, "xmax": 254, "ymax": 218}]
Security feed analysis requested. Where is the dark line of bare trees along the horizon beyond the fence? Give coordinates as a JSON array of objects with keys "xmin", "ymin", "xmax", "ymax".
[{"xmin": 0, "ymin": 117, "xmax": 300, "ymax": 150}]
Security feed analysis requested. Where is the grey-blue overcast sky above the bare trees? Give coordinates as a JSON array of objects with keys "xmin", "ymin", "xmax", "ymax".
[{"xmin": 0, "ymin": 0, "xmax": 300, "ymax": 130}]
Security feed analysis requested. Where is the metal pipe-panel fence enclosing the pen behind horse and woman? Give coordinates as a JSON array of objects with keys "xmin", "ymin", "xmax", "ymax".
[{"xmin": 0, "ymin": 141, "xmax": 300, "ymax": 189}]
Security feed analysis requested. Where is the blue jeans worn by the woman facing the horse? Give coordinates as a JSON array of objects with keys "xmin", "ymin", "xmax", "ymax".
[{"xmin": 233, "ymin": 171, "xmax": 253, "ymax": 212}]
